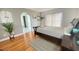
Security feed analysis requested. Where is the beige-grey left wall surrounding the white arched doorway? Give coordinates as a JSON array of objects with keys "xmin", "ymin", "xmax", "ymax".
[{"xmin": 0, "ymin": 8, "xmax": 39, "ymax": 39}]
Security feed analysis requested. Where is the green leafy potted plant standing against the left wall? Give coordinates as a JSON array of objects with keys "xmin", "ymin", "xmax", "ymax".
[{"xmin": 2, "ymin": 22, "xmax": 14, "ymax": 40}]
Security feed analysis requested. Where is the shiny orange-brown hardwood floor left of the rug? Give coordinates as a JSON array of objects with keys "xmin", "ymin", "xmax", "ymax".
[{"xmin": 0, "ymin": 33, "xmax": 34, "ymax": 51}]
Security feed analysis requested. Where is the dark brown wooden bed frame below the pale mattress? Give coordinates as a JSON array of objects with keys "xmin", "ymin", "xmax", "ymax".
[{"xmin": 36, "ymin": 32, "xmax": 72, "ymax": 51}]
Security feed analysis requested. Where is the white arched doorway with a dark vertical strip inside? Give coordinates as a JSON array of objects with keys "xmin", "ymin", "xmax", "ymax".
[{"xmin": 21, "ymin": 13, "xmax": 31, "ymax": 33}]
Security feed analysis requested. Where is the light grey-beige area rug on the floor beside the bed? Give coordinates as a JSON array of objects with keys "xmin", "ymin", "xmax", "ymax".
[{"xmin": 30, "ymin": 38, "xmax": 60, "ymax": 51}]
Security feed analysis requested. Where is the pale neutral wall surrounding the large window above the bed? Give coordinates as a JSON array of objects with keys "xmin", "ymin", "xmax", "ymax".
[{"xmin": 42, "ymin": 8, "xmax": 79, "ymax": 26}]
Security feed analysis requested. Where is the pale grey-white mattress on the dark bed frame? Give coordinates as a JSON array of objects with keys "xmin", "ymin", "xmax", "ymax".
[{"xmin": 37, "ymin": 27, "xmax": 64, "ymax": 39}]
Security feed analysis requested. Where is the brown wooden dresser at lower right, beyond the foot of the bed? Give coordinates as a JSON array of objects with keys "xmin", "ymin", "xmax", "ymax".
[{"xmin": 61, "ymin": 35, "xmax": 79, "ymax": 51}]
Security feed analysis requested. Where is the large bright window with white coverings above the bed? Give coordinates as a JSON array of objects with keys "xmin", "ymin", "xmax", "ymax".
[{"xmin": 45, "ymin": 13, "xmax": 63, "ymax": 27}]
